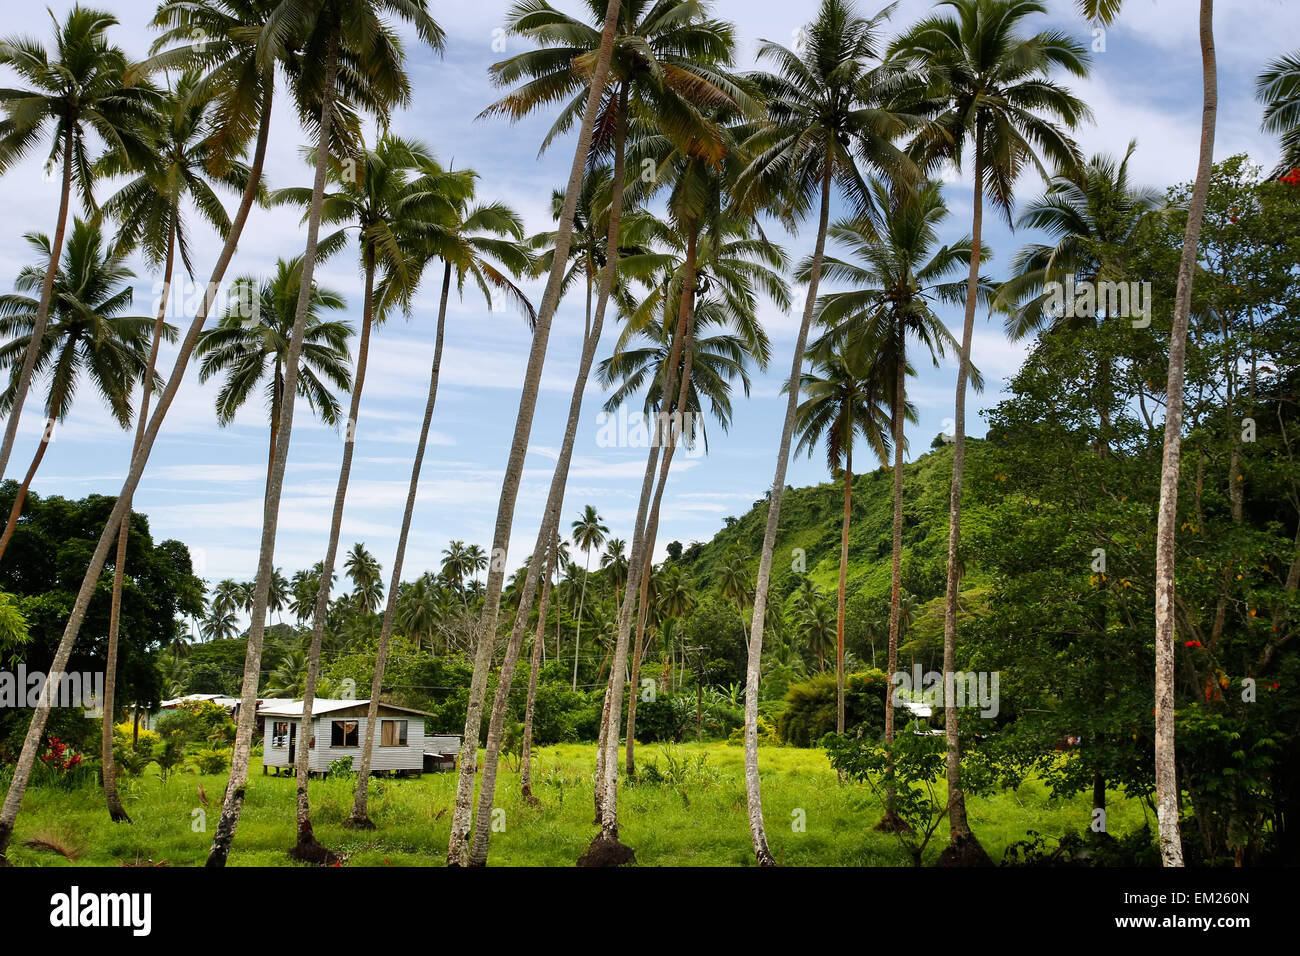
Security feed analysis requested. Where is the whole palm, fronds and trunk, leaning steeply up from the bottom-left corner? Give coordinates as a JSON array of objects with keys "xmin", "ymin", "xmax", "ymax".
[{"xmin": 0, "ymin": 0, "xmax": 291, "ymax": 860}]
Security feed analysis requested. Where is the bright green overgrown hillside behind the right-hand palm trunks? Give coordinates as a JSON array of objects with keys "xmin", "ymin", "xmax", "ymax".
[{"xmin": 680, "ymin": 438, "xmax": 992, "ymax": 663}]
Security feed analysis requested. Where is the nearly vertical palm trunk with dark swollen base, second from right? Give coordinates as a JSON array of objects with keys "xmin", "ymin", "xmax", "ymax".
[{"xmin": 935, "ymin": 120, "xmax": 987, "ymax": 862}]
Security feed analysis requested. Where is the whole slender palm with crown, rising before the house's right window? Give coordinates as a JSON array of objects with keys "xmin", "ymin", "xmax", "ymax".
[{"xmin": 348, "ymin": 166, "xmax": 537, "ymax": 827}]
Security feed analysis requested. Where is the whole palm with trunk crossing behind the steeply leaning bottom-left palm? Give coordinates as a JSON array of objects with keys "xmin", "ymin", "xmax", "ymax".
[{"xmin": 98, "ymin": 70, "xmax": 248, "ymax": 822}]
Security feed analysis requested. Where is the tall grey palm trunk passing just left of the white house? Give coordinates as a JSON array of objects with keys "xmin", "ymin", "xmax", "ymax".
[{"xmin": 207, "ymin": 37, "xmax": 339, "ymax": 866}]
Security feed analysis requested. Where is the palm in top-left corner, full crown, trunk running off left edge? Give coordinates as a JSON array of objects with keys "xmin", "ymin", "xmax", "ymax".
[{"xmin": 0, "ymin": 7, "xmax": 160, "ymax": 486}]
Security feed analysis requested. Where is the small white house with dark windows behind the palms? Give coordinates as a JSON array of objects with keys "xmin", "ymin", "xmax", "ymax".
[{"xmin": 257, "ymin": 698, "xmax": 432, "ymax": 774}]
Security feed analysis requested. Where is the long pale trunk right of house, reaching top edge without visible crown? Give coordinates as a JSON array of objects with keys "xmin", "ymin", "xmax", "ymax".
[{"xmin": 447, "ymin": 0, "xmax": 621, "ymax": 866}]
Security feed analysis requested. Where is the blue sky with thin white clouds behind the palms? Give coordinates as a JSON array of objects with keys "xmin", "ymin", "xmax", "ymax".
[{"xmin": 0, "ymin": 0, "xmax": 1300, "ymax": 608}]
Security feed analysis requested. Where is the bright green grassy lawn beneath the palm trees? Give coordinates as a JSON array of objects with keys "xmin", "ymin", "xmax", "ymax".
[{"xmin": 10, "ymin": 744, "xmax": 1143, "ymax": 866}]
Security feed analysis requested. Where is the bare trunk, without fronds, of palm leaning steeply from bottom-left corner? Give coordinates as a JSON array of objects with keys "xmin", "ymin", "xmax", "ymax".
[{"xmin": 0, "ymin": 78, "xmax": 273, "ymax": 865}]
